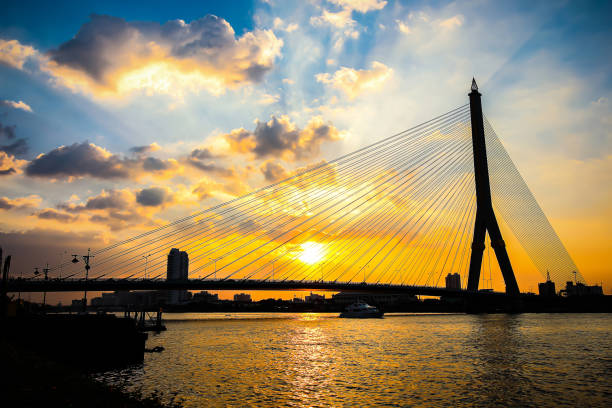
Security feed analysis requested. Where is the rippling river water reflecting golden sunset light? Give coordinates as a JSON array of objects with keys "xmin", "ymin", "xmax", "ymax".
[{"xmin": 97, "ymin": 314, "xmax": 612, "ymax": 407}]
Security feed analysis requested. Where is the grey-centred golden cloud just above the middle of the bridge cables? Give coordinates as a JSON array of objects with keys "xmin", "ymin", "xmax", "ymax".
[{"xmin": 223, "ymin": 116, "xmax": 343, "ymax": 160}]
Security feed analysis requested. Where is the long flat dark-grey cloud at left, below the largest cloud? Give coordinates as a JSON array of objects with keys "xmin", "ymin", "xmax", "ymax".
[{"xmin": 25, "ymin": 142, "xmax": 177, "ymax": 179}]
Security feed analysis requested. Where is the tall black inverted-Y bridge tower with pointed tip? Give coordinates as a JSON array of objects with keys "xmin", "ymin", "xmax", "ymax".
[{"xmin": 467, "ymin": 79, "xmax": 519, "ymax": 295}]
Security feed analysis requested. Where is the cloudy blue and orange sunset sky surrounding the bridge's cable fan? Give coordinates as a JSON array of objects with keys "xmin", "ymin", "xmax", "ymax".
[{"xmin": 0, "ymin": 0, "xmax": 612, "ymax": 300}]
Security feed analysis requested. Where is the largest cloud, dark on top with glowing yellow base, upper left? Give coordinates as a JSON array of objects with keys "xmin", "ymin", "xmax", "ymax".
[{"xmin": 45, "ymin": 14, "xmax": 283, "ymax": 99}]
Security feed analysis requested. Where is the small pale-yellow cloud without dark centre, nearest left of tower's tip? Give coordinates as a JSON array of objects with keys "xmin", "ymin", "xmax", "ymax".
[{"xmin": 315, "ymin": 61, "xmax": 393, "ymax": 99}]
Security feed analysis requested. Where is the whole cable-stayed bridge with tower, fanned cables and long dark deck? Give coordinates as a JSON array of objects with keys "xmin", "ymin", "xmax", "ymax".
[{"xmin": 5, "ymin": 80, "xmax": 584, "ymax": 296}]
